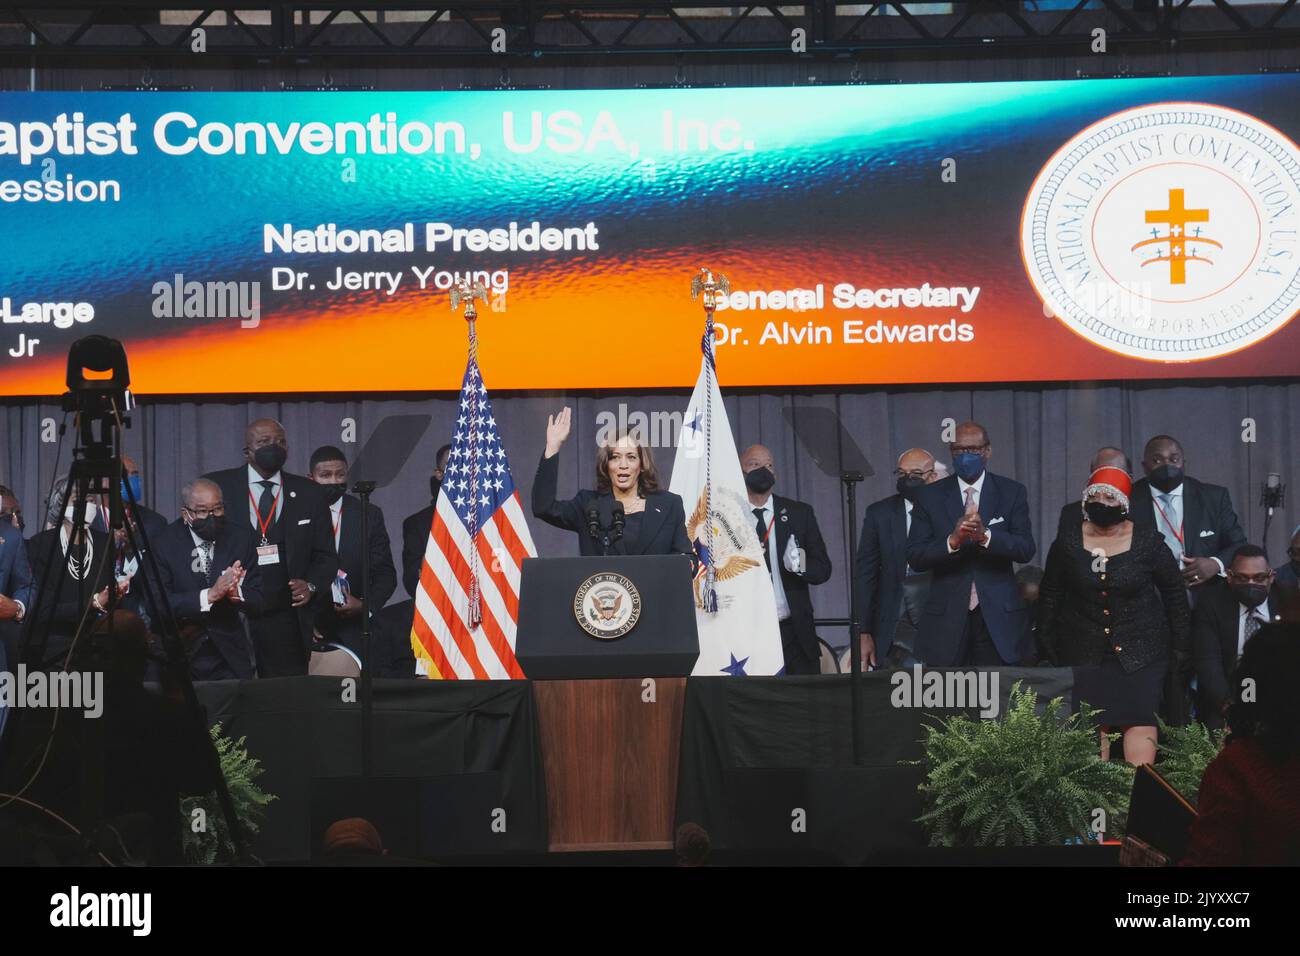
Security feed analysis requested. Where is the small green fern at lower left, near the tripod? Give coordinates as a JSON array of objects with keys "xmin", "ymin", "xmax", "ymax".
[{"xmin": 181, "ymin": 723, "xmax": 276, "ymax": 864}]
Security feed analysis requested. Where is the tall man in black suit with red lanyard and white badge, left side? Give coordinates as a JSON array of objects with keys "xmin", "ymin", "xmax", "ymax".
[{"xmin": 204, "ymin": 419, "xmax": 338, "ymax": 678}]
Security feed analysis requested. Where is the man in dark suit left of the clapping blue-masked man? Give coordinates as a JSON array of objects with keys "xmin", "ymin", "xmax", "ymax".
[{"xmin": 853, "ymin": 449, "xmax": 939, "ymax": 669}]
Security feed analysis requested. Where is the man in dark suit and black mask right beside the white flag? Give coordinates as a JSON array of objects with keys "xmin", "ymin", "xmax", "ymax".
[{"xmin": 740, "ymin": 445, "xmax": 831, "ymax": 674}]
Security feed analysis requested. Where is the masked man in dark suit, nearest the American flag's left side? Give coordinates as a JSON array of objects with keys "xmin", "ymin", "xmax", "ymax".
[{"xmin": 308, "ymin": 445, "xmax": 398, "ymax": 663}]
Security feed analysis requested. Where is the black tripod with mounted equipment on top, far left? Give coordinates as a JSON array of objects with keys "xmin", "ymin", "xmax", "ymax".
[{"xmin": 0, "ymin": 336, "xmax": 244, "ymax": 856}]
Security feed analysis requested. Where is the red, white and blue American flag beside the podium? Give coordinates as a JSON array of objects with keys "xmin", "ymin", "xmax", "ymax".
[{"xmin": 411, "ymin": 354, "xmax": 537, "ymax": 680}]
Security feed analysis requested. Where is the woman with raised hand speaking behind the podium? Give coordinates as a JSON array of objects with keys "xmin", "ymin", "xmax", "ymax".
[{"xmin": 533, "ymin": 407, "xmax": 693, "ymax": 555}]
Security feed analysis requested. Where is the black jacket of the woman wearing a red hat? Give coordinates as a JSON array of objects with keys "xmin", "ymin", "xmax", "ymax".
[{"xmin": 1039, "ymin": 520, "xmax": 1190, "ymax": 671}]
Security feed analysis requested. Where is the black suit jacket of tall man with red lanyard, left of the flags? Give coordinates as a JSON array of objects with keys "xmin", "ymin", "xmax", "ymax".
[{"xmin": 204, "ymin": 464, "xmax": 338, "ymax": 648}]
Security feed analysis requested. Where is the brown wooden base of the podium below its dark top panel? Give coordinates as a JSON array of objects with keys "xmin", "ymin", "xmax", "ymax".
[{"xmin": 533, "ymin": 678, "xmax": 686, "ymax": 852}]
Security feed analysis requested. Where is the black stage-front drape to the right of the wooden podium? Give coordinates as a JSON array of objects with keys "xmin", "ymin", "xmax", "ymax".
[{"xmin": 676, "ymin": 667, "xmax": 1074, "ymax": 865}]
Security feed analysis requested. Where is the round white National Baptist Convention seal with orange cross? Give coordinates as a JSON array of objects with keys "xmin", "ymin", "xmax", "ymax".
[{"xmin": 1021, "ymin": 103, "xmax": 1300, "ymax": 362}]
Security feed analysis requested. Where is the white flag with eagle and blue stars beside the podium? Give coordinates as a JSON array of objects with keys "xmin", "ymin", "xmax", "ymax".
[{"xmin": 670, "ymin": 333, "xmax": 785, "ymax": 676}]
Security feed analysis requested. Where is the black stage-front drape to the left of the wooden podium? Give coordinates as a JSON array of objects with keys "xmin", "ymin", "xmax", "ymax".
[{"xmin": 196, "ymin": 678, "xmax": 546, "ymax": 861}]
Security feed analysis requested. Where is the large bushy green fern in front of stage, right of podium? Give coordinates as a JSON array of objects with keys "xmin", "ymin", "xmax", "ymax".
[{"xmin": 905, "ymin": 682, "xmax": 1134, "ymax": 847}]
